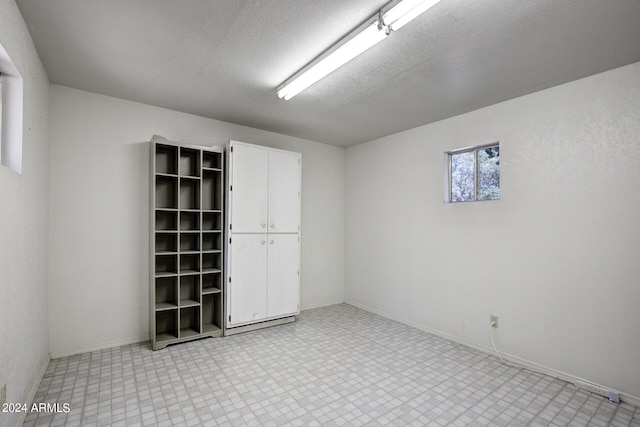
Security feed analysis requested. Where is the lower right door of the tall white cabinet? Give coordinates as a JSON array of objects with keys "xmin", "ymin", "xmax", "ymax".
[{"xmin": 267, "ymin": 234, "xmax": 300, "ymax": 317}]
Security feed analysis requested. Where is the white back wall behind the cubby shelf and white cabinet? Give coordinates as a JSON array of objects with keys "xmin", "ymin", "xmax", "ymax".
[{"xmin": 49, "ymin": 85, "xmax": 344, "ymax": 357}]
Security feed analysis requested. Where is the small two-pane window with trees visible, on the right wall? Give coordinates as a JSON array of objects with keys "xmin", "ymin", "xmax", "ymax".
[{"xmin": 446, "ymin": 143, "xmax": 500, "ymax": 203}]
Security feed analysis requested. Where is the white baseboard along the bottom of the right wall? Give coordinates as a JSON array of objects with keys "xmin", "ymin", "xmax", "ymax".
[{"xmin": 345, "ymin": 301, "xmax": 640, "ymax": 406}]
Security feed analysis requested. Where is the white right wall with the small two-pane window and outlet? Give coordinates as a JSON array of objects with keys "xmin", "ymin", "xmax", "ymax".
[{"xmin": 345, "ymin": 63, "xmax": 640, "ymax": 399}]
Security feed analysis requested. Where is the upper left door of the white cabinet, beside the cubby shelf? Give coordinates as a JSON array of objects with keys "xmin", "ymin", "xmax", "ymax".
[{"xmin": 229, "ymin": 145, "xmax": 269, "ymax": 233}]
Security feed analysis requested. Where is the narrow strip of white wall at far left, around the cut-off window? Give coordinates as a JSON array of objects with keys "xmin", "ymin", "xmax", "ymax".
[{"xmin": 0, "ymin": 1, "xmax": 49, "ymax": 426}]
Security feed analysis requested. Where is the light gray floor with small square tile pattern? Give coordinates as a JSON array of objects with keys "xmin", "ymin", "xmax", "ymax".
[{"xmin": 25, "ymin": 305, "xmax": 640, "ymax": 427}]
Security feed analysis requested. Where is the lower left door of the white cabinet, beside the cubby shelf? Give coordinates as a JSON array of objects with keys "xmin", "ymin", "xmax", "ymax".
[{"xmin": 227, "ymin": 234, "xmax": 267, "ymax": 326}]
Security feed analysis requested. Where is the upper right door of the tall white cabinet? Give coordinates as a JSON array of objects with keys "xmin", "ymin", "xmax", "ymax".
[{"xmin": 269, "ymin": 151, "xmax": 301, "ymax": 233}]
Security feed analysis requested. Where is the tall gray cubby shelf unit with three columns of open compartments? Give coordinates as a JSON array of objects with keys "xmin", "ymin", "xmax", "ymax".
[{"xmin": 149, "ymin": 136, "xmax": 224, "ymax": 350}]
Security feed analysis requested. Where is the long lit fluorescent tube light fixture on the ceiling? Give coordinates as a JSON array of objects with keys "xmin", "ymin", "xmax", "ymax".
[{"xmin": 277, "ymin": 0, "xmax": 440, "ymax": 100}]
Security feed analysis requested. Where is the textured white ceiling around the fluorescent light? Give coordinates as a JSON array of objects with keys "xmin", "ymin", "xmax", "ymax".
[{"xmin": 17, "ymin": 0, "xmax": 640, "ymax": 146}]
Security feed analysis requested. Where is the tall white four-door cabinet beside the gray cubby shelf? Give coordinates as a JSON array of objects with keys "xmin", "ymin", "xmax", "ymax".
[{"xmin": 226, "ymin": 141, "xmax": 301, "ymax": 334}]
